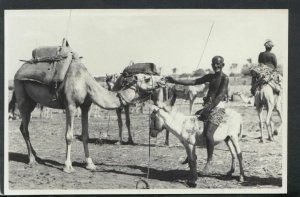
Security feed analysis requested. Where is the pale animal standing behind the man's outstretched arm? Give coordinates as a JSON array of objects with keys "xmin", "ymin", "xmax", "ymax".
[{"xmin": 168, "ymin": 84, "xmax": 208, "ymax": 115}]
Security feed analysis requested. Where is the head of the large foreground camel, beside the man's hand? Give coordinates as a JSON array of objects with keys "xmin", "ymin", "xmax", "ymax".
[{"xmin": 133, "ymin": 74, "xmax": 166, "ymax": 92}]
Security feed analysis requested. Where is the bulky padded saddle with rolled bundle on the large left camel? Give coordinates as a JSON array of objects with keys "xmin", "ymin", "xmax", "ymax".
[{"xmin": 14, "ymin": 45, "xmax": 76, "ymax": 85}]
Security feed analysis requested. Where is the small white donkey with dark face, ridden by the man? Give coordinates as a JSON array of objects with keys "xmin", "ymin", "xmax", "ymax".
[{"xmin": 150, "ymin": 106, "xmax": 244, "ymax": 187}]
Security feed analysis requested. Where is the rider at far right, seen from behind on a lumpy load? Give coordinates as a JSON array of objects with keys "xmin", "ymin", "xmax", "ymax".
[{"xmin": 251, "ymin": 40, "xmax": 282, "ymax": 95}]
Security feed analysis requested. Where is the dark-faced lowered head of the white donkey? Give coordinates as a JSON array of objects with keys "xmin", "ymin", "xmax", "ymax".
[{"xmin": 150, "ymin": 105, "xmax": 164, "ymax": 137}]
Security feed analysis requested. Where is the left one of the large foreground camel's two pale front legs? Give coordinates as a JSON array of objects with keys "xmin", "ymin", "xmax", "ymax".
[{"xmin": 63, "ymin": 104, "xmax": 77, "ymax": 173}]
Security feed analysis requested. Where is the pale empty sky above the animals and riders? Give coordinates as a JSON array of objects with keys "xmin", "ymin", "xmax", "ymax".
[{"xmin": 5, "ymin": 9, "xmax": 288, "ymax": 79}]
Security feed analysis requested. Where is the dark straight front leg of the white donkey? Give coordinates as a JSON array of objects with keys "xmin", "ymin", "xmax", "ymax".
[{"xmin": 184, "ymin": 144, "xmax": 198, "ymax": 187}]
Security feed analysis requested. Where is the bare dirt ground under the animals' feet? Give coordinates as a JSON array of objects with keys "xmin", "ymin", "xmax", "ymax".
[{"xmin": 8, "ymin": 101, "xmax": 285, "ymax": 193}]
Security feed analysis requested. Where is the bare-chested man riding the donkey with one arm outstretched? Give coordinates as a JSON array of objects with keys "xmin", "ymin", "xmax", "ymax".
[{"xmin": 166, "ymin": 56, "xmax": 229, "ymax": 177}]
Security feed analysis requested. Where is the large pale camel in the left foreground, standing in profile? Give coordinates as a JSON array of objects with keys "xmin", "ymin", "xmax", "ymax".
[{"xmin": 14, "ymin": 42, "xmax": 161, "ymax": 173}]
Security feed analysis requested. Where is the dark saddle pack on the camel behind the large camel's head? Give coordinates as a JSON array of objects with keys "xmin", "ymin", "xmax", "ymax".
[{"xmin": 123, "ymin": 63, "xmax": 159, "ymax": 75}]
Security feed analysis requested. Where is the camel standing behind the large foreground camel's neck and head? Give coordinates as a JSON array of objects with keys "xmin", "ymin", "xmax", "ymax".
[{"xmin": 105, "ymin": 74, "xmax": 169, "ymax": 145}]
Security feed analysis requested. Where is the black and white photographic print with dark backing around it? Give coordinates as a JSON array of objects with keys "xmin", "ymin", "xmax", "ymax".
[{"xmin": 4, "ymin": 9, "xmax": 289, "ymax": 195}]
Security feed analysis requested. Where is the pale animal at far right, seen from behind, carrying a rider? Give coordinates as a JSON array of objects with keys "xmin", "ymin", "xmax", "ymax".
[{"xmin": 254, "ymin": 84, "xmax": 282, "ymax": 143}]
